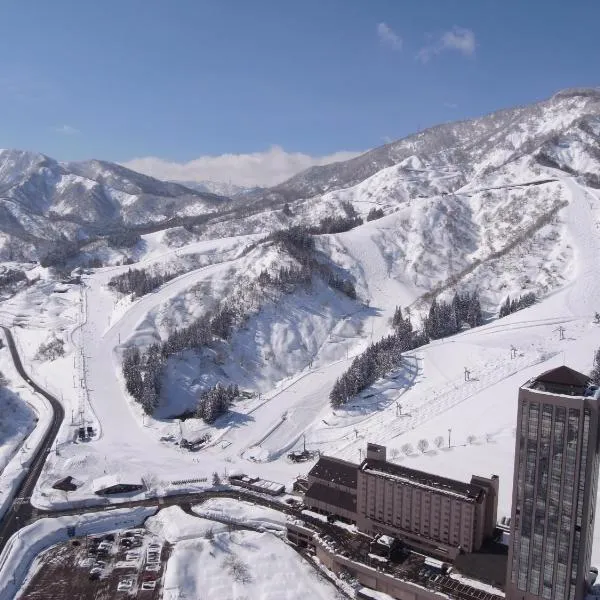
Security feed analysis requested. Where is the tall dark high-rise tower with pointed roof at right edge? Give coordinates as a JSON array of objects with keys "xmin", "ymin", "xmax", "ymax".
[{"xmin": 506, "ymin": 366, "xmax": 600, "ymax": 600}]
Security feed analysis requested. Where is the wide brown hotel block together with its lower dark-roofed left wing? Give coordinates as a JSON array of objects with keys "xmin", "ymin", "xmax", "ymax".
[{"xmin": 304, "ymin": 444, "xmax": 498, "ymax": 560}]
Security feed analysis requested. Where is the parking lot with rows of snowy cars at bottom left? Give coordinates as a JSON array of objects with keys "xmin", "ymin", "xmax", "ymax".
[{"xmin": 22, "ymin": 529, "xmax": 171, "ymax": 600}]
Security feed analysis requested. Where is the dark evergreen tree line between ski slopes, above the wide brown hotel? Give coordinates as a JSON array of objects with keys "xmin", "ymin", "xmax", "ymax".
[{"xmin": 329, "ymin": 291, "xmax": 483, "ymax": 407}]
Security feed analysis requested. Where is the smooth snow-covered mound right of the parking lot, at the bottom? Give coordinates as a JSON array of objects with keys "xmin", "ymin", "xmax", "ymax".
[{"xmin": 146, "ymin": 508, "xmax": 338, "ymax": 600}]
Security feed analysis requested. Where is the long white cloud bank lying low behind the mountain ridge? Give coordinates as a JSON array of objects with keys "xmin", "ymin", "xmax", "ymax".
[{"xmin": 123, "ymin": 146, "xmax": 362, "ymax": 187}]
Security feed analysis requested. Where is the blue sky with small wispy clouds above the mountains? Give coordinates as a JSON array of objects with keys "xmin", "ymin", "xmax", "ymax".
[{"xmin": 0, "ymin": 0, "xmax": 600, "ymax": 181}]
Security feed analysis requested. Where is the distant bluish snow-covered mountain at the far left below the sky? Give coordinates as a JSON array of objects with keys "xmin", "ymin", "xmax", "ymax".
[{"xmin": 0, "ymin": 150, "xmax": 229, "ymax": 260}]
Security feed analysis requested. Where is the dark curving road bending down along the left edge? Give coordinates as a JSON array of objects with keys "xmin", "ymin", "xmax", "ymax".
[{"xmin": 0, "ymin": 326, "xmax": 65, "ymax": 554}]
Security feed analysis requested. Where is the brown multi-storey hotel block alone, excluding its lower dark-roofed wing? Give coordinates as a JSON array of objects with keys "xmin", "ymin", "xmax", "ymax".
[{"xmin": 357, "ymin": 444, "xmax": 498, "ymax": 560}]
